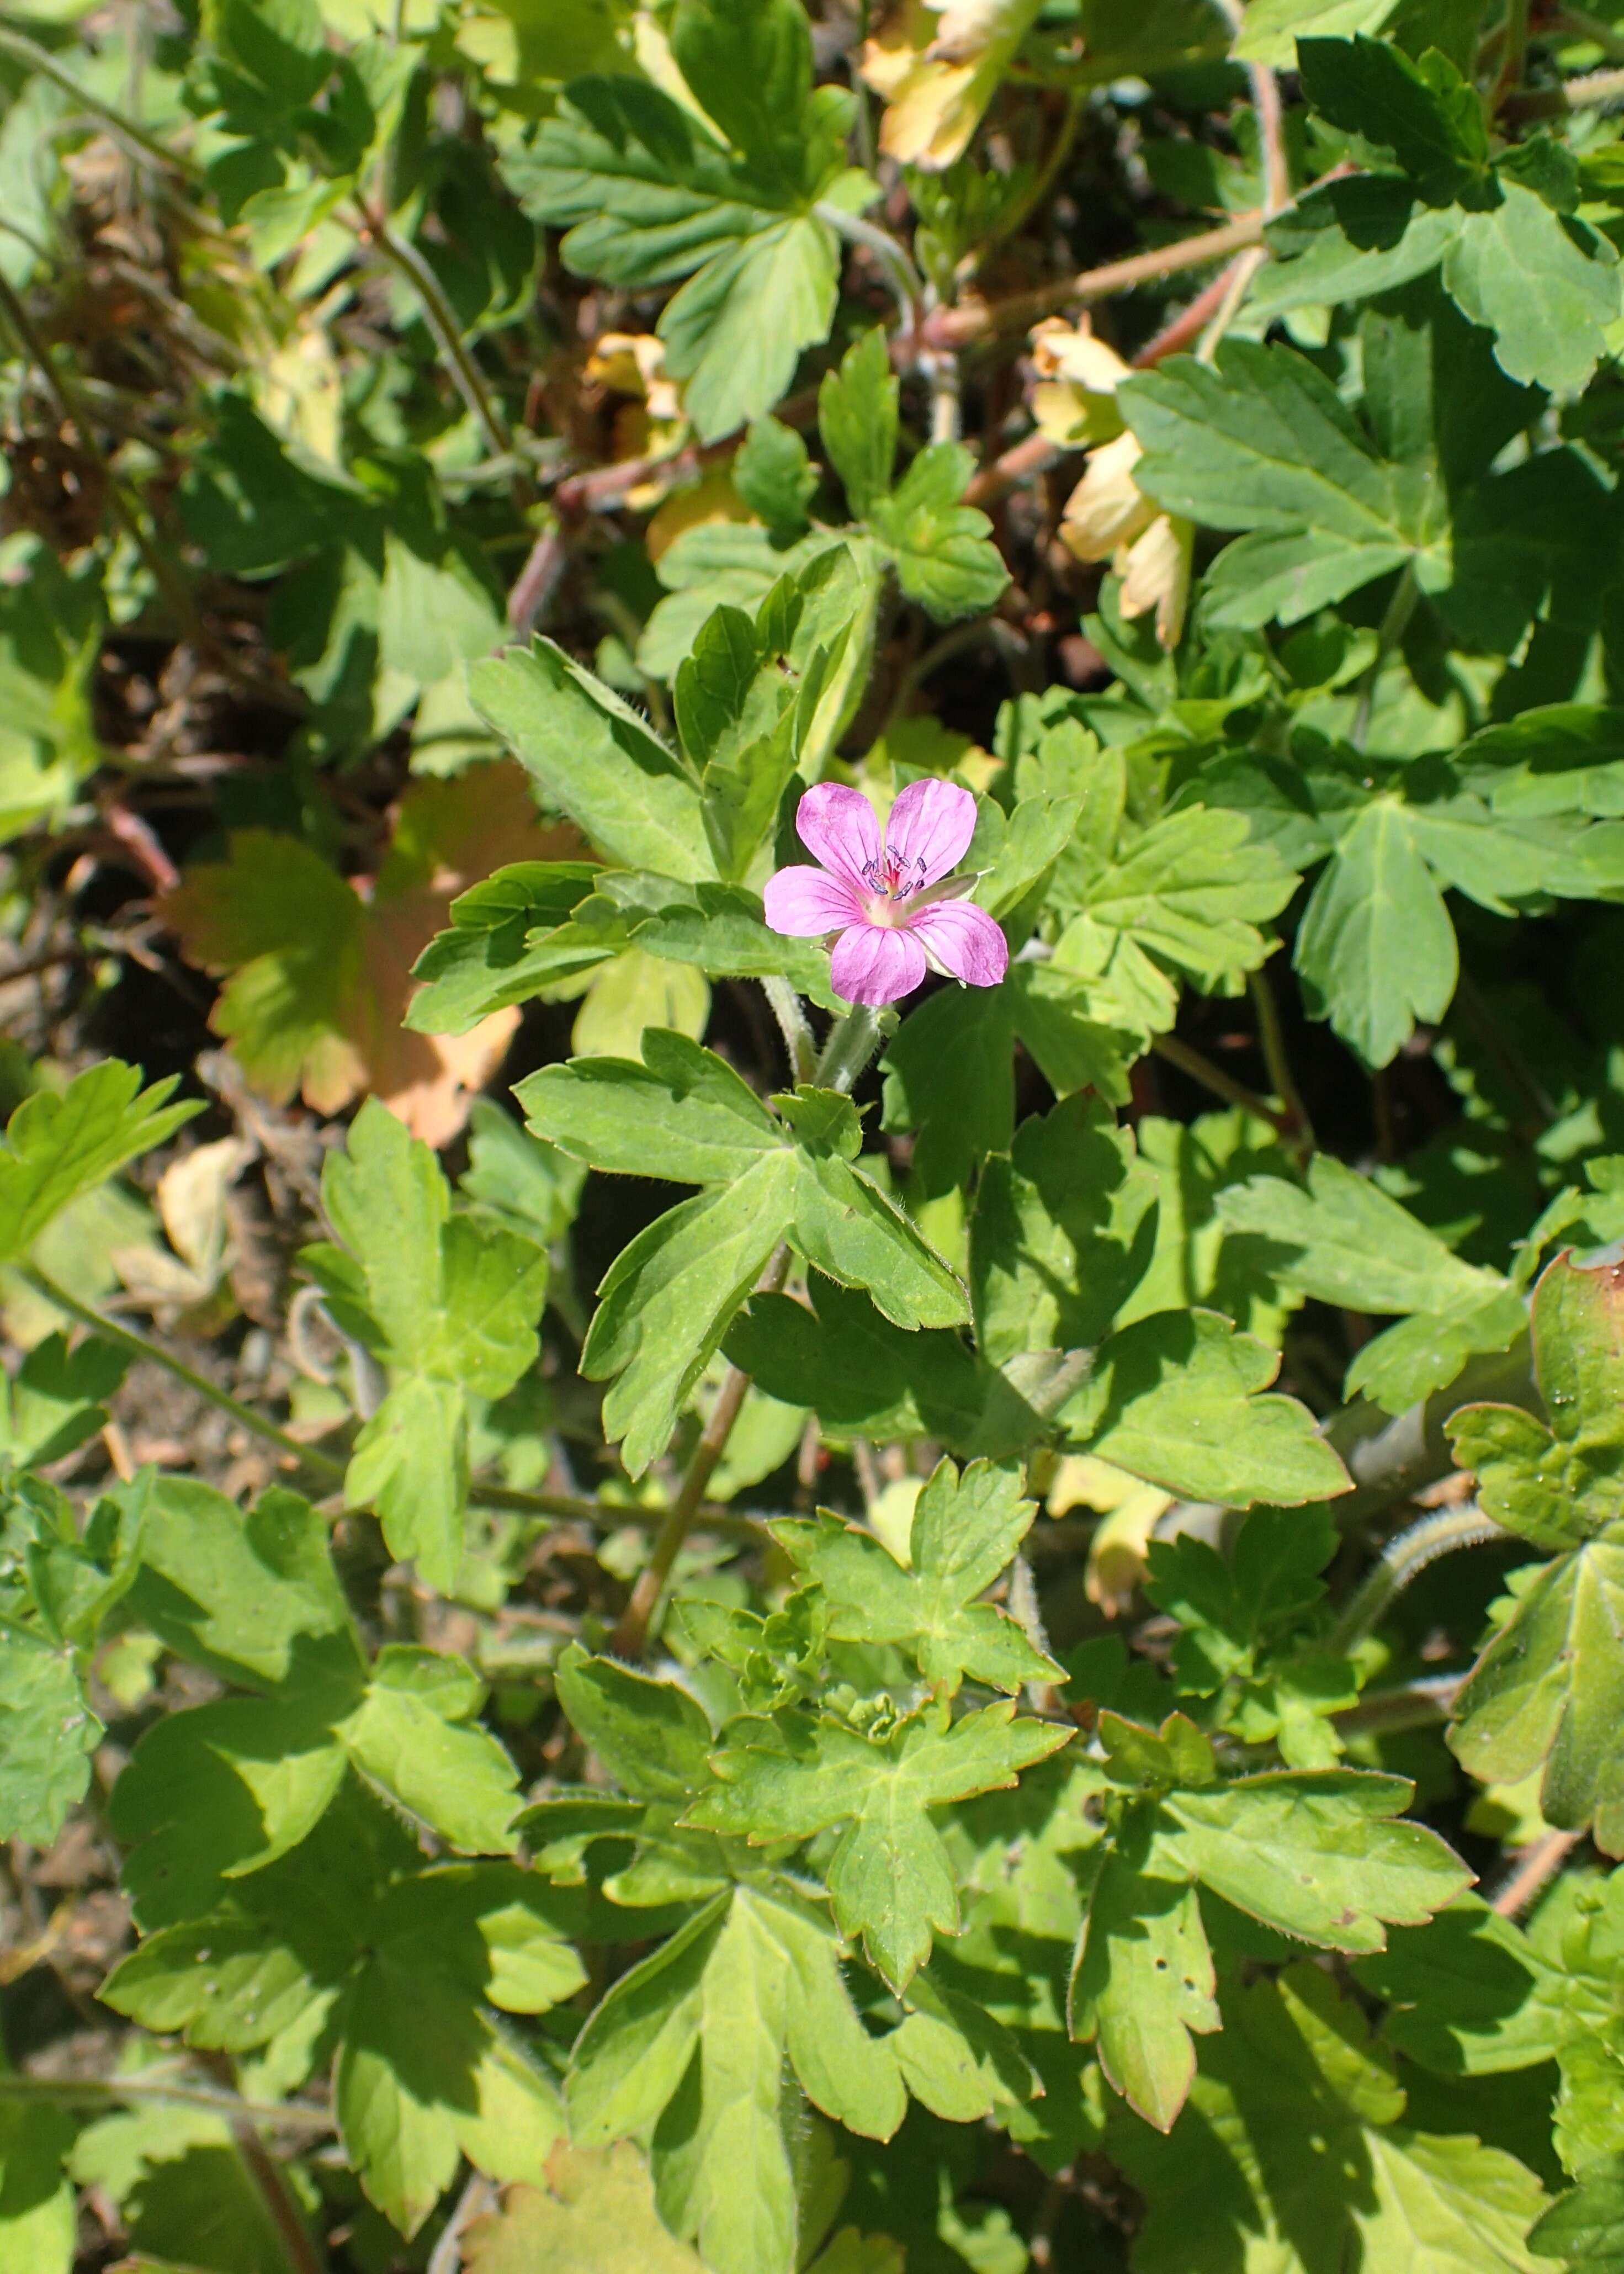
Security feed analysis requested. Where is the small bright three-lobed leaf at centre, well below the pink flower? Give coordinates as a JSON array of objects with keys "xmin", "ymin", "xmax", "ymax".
[{"xmin": 773, "ymin": 1460, "xmax": 1060, "ymax": 1697}]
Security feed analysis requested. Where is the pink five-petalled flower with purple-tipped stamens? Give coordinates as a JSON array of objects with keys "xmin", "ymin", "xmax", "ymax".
[{"xmin": 764, "ymin": 780, "xmax": 1010, "ymax": 1003}]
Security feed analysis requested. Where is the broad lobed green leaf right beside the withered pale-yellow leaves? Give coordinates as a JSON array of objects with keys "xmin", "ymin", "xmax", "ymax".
[{"xmin": 1117, "ymin": 341, "xmax": 1447, "ymax": 626}]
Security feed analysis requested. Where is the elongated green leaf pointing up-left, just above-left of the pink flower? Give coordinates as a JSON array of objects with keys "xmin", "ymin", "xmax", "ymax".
[{"xmin": 469, "ymin": 639, "xmax": 717, "ymax": 882}]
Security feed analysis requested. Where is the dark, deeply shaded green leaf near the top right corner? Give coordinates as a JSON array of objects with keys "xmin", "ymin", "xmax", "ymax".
[{"xmin": 1297, "ymin": 34, "xmax": 1490, "ymax": 205}]
